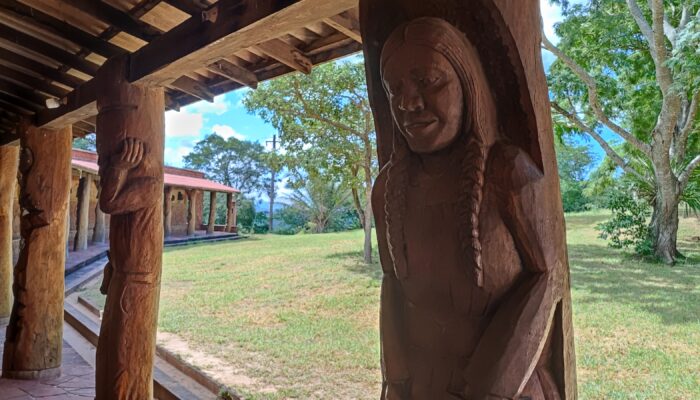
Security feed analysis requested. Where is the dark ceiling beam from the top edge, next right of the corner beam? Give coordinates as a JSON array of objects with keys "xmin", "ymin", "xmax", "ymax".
[{"xmin": 63, "ymin": 0, "xmax": 162, "ymax": 42}]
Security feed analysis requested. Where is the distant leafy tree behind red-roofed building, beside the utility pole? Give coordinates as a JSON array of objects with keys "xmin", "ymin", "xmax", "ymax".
[{"xmin": 184, "ymin": 134, "xmax": 268, "ymax": 194}]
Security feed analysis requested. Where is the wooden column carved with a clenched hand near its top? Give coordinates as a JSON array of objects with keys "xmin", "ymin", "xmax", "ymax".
[{"xmin": 95, "ymin": 57, "xmax": 165, "ymax": 400}]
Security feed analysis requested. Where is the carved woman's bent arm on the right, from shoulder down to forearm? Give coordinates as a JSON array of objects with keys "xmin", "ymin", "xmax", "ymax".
[{"xmin": 465, "ymin": 147, "xmax": 558, "ymax": 399}]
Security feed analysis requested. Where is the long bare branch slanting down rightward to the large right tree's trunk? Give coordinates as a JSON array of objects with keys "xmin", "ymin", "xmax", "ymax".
[{"xmin": 542, "ymin": 31, "xmax": 651, "ymax": 157}]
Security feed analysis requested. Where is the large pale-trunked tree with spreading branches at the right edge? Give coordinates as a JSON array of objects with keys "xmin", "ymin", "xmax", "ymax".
[{"xmin": 542, "ymin": 0, "xmax": 700, "ymax": 263}]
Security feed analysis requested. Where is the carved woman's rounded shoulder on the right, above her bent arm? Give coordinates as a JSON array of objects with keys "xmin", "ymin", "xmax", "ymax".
[{"xmin": 486, "ymin": 141, "xmax": 543, "ymax": 192}]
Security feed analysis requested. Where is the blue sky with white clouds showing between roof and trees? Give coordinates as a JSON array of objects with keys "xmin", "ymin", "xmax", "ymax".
[{"xmin": 165, "ymin": 0, "xmax": 611, "ymax": 180}]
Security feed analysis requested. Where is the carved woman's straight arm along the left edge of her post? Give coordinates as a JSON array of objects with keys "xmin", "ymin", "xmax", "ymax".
[{"xmin": 372, "ymin": 167, "xmax": 410, "ymax": 400}]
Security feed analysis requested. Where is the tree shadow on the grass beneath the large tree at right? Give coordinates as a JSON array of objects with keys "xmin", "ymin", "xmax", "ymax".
[{"xmin": 569, "ymin": 245, "xmax": 700, "ymax": 324}]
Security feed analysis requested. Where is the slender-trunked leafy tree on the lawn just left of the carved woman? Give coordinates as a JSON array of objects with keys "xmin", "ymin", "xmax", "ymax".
[{"xmin": 243, "ymin": 61, "xmax": 377, "ymax": 263}]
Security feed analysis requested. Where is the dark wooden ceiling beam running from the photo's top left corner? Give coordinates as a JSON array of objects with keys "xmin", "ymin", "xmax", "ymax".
[{"xmin": 0, "ymin": 0, "xmax": 125, "ymax": 58}]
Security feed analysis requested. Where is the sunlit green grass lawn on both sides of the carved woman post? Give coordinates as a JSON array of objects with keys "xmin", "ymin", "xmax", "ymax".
[{"xmin": 79, "ymin": 212, "xmax": 700, "ymax": 400}]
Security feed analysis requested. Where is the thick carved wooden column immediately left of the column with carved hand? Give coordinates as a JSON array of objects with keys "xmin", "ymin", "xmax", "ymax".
[{"xmin": 2, "ymin": 126, "xmax": 72, "ymax": 379}]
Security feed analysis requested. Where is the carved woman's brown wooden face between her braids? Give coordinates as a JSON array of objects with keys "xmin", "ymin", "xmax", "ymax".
[{"xmin": 383, "ymin": 43, "xmax": 464, "ymax": 154}]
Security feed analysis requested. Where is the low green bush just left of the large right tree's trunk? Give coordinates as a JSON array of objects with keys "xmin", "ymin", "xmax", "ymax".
[{"xmin": 596, "ymin": 190, "xmax": 653, "ymax": 255}]
